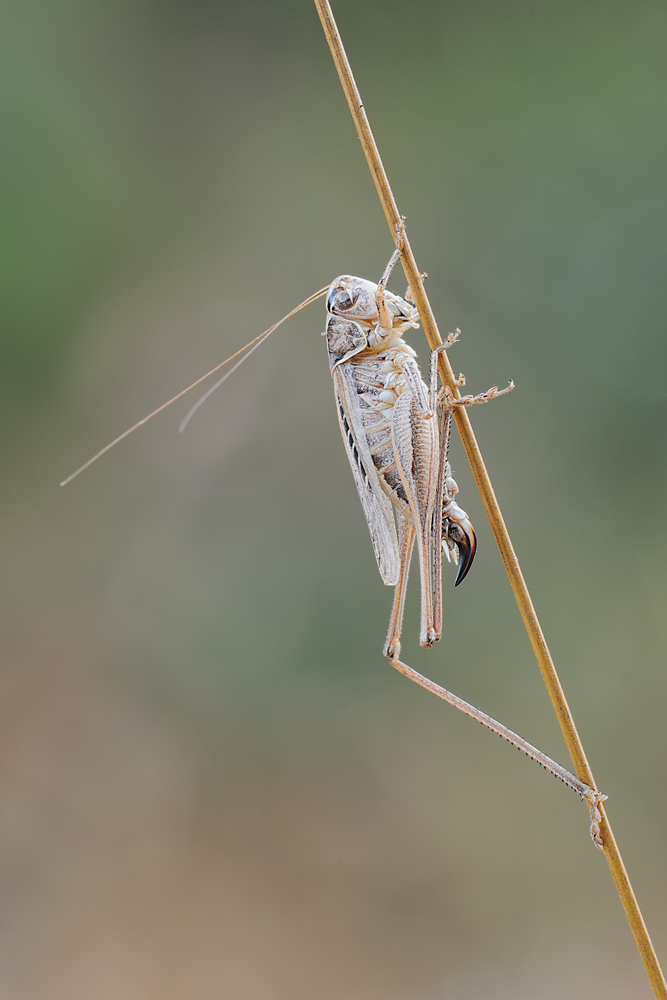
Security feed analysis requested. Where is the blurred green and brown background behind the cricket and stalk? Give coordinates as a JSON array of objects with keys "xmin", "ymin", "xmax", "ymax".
[{"xmin": 0, "ymin": 0, "xmax": 667, "ymax": 1000}]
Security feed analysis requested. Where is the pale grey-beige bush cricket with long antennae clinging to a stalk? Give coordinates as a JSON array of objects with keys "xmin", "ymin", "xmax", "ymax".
[{"xmin": 61, "ymin": 242, "xmax": 607, "ymax": 849}]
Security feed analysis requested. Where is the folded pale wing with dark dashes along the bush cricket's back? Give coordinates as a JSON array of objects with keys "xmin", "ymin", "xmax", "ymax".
[{"xmin": 333, "ymin": 364, "xmax": 400, "ymax": 587}]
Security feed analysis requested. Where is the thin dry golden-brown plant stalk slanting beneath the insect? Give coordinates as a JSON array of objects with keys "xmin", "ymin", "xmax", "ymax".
[{"xmin": 314, "ymin": 0, "xmax": 667, "ymax": 1000}]
